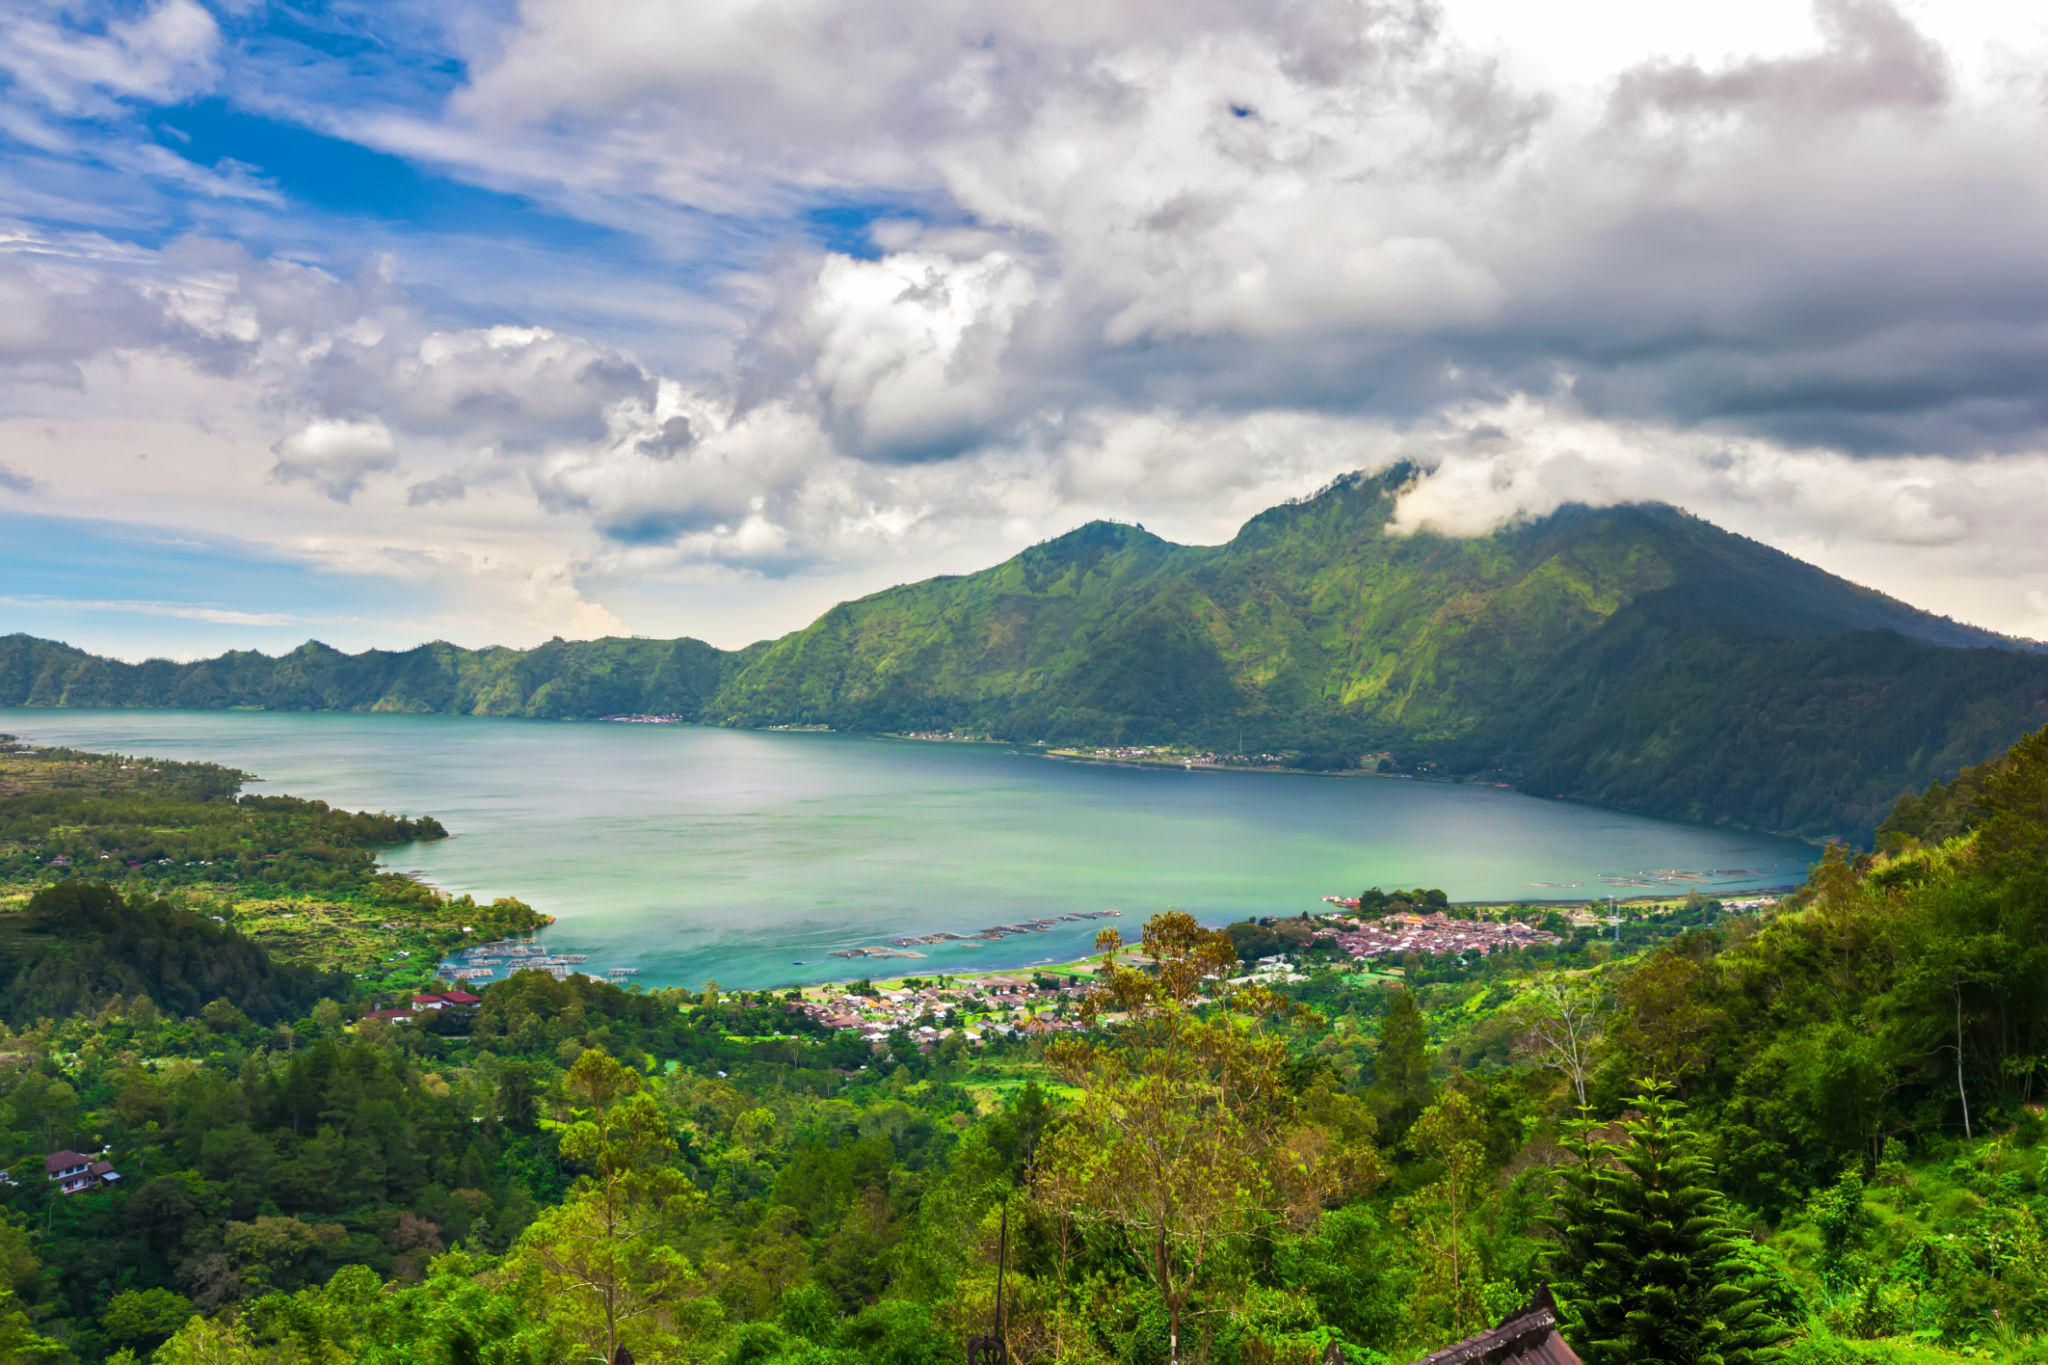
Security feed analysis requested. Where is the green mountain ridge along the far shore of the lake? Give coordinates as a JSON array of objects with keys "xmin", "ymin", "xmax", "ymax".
[{"xmin": 0, "ymin": 471, "xmax": 2048, "ymax": 833}]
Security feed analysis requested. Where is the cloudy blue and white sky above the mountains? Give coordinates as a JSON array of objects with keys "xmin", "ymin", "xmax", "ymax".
[{"xmin": 0, "ymin": 0, "xmax": 2048, "ymax": 659}]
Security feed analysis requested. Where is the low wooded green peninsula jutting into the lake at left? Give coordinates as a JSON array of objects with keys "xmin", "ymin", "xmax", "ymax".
[{"xmin": 0, "ymin": 735, "xmax": 547, "ymax": 994}]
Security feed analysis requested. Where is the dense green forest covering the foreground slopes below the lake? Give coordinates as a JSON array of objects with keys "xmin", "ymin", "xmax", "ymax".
[{"xmin": 0, "ymin": 731, "xmax": 2048, "ymax": 1365}]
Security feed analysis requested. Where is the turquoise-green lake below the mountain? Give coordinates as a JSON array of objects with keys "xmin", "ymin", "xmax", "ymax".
[{"xmin": 0, "ymin": 708, "xmax": 1815, "ymax": 986}]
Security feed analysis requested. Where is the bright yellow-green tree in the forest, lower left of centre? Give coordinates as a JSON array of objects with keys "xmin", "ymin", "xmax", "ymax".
[{"xmin": 520, "ymin": 1048, "xmax": 702, "ymax": 1363}]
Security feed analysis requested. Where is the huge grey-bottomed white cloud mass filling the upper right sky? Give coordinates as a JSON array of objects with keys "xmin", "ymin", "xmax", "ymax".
[{"xmin": 399, "ymin": 0, "xmax": 2048, "ymax": 458}]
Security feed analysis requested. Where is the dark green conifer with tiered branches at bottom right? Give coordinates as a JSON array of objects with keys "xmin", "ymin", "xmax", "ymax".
[{"xmin": 1550, "ymin": 1085, "xmax": 1786, "ymax": 1365}]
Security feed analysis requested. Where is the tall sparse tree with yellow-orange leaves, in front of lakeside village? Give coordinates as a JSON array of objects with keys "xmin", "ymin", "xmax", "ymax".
[{"xmin": 1040, "ymin": 913, "xmax": 1378, "ymax": 1361}]
